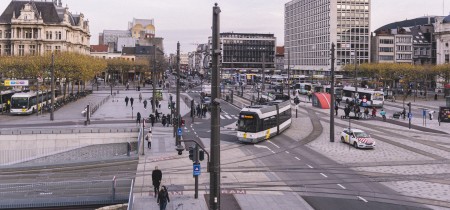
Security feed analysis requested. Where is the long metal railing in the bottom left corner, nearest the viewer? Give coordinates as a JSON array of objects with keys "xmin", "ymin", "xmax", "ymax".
[{"xmin": 0, "ymin": 179, "xmax": 133, "ymax": 209}]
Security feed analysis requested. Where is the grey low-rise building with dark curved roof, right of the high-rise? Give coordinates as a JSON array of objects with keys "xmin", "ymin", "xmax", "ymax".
[{"xmin": 371, "ymin": 16, "xmax": 443, "ymax": 65}]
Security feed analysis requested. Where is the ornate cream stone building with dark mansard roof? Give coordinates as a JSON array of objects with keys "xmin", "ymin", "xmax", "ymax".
[{"xmin": 0, "ymin": 0, "xmax": 90, "ymax": 56}]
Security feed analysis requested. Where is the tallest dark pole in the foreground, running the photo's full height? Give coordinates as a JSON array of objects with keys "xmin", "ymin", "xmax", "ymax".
[{"xmin": 209, "ymin": 3, "xmax": 221, "ymax": 210}]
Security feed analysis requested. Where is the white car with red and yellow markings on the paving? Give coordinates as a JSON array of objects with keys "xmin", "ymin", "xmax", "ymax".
[{"xmin": 341, "ymin": 128, "xmax": 375, "ymax": 149}]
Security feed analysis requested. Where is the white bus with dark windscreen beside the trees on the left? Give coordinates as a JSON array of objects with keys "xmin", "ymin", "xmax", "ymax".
[{"xmin": 10, "ymin": 92, "xmax": 51, "ymax": 114}]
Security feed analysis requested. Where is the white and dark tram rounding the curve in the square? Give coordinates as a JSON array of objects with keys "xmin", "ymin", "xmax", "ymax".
[{"xmin": 237, "ymin": 100, "xmax": 292, "ymax": 143}]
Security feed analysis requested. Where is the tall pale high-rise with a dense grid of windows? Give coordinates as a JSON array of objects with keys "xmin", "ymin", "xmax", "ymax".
[{"xmin": 284, "ymin": 0, "xmax": 371, "ymax": 75}]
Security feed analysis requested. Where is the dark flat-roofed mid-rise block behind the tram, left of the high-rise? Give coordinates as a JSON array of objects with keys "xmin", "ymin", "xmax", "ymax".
[{"xmin": 208, "ymin": 32, "xmax": 277, "ymax": 78}]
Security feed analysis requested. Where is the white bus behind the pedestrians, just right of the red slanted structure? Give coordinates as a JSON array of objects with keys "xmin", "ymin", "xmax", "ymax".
[{"xmin": 342, "ymin": 86, "xmax": 384, "ymax": 108}]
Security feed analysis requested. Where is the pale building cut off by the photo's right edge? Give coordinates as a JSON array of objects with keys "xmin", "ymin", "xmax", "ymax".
[{"xmin": 434, "ymin": 15, "xmax": 450, "ymax": 64}]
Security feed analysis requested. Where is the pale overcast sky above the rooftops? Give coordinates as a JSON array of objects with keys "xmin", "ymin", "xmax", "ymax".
[{"xmin": 0, "ymin": 0, "xmax": 450, "ymax": 53}]
